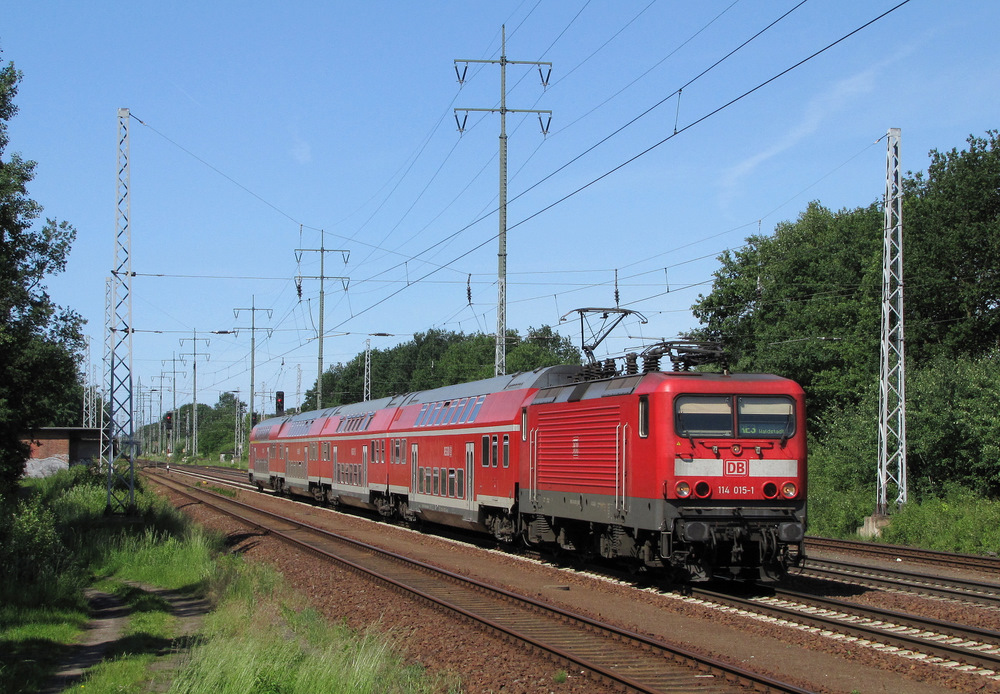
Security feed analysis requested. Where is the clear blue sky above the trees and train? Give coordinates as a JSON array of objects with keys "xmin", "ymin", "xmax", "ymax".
[{"xmin": 0, "ymin": 0, "xmax": 1000, "ymax": 422}]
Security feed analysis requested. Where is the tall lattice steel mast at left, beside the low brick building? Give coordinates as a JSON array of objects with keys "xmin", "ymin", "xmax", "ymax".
[{"xmin": 101, "ymin": 108, "xmax": 138, "ymax": 514}]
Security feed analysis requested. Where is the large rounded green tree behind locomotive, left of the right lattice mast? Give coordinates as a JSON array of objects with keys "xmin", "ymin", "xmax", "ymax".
[{"xmin": 692, "ymin": 202, "xmax": 882, "ymax": 418}]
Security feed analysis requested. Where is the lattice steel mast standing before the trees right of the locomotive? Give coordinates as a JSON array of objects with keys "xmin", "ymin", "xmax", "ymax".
[{"xmin": 875, "ymin": 128, "xmax": 906, "ymax": 516}]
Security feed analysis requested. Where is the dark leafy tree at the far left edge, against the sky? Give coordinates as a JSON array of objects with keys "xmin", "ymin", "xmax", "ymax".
[{"xmin": 0, "ymin": 57, "xmax": 83, "ymax": 494}]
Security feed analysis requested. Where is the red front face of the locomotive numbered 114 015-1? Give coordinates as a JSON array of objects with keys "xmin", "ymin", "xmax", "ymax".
[{"xmin": 661, "ymin": 374, "xmax": 806, "ymax": 580}]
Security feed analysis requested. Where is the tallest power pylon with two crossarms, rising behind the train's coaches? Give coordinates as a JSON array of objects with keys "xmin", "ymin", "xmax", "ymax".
[{"xmin": 455, "ymin": 25, "xmax": 552, "ymax": 376}]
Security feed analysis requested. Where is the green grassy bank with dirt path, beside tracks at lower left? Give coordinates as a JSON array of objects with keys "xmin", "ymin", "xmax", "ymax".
[{"xmin": 0, "ymin": 468, "xmax": 460, "ymax": 694}]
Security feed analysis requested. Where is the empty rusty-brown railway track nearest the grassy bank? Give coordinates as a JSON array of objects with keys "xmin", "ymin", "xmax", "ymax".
[{"xmin": 150, "ymin": 475, "xmax": 807, "ymax": 694}]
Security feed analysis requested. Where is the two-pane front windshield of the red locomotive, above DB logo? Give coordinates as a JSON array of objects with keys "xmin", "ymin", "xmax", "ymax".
[{"xmin": 674, "ymin": 395, "xmax": 795, "ymax": 439}]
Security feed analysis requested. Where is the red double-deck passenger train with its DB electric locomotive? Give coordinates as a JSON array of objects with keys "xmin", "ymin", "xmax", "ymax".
[{"xmin": 249, "ymin": 346, "xmax": 806, "ymax": 580}]
